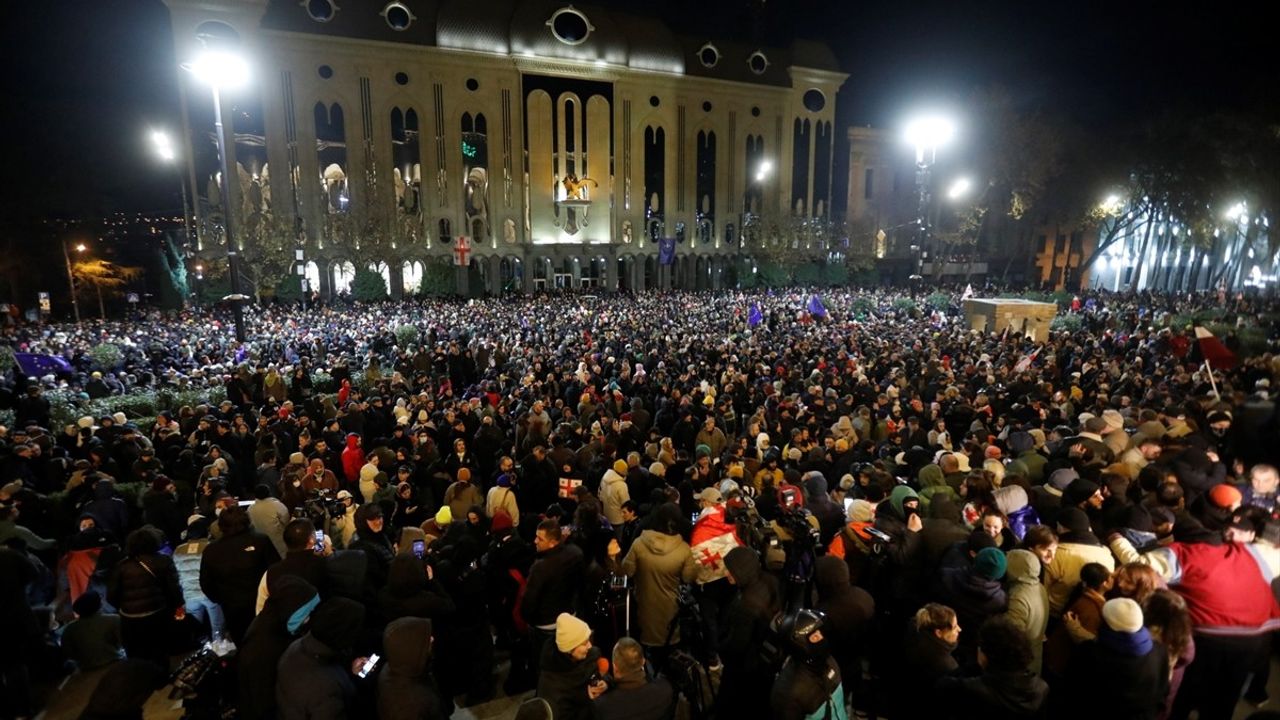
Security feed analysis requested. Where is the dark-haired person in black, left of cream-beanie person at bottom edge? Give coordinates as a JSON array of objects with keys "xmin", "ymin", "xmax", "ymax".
[{"xmin": 937, "ymin": 618, "xmax": 1048, "ymax": 720}]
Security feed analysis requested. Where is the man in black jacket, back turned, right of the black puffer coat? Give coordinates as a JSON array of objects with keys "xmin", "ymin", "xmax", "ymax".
[{"xmin": 200, "ymin": 506, "xmax": 280, "ymax": 643}]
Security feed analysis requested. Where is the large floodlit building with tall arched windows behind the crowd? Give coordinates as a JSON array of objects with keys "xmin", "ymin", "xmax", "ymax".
[{"xmin": 166, "ymin": 0, "xmax": 847, "ymax": 295}]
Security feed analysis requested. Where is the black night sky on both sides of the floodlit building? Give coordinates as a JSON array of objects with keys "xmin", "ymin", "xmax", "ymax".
[{"xmin": 0, "ymin": 0, "xmax": 1280, "ymax": 218}]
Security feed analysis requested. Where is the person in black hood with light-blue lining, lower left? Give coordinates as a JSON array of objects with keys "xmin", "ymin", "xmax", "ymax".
[{"xmin": 236, "ymin": 575, "xmax": 320, "ymax": 720}]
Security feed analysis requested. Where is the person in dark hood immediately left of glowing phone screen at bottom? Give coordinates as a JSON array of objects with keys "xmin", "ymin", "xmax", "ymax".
[{"xmin": 275, "ymin": 597, "xmax": 367, "ymax": 720}]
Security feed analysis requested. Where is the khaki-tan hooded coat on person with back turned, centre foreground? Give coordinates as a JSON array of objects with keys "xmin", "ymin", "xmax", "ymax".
[{"xmin": 618, "ymin": 527, "xmax": 698, "ymax": 646}]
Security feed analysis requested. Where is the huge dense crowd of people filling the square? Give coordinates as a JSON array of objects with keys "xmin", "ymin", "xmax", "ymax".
[{"xmin": 0, "ymin": 290, "xmax": 1280, "ymax": 720}]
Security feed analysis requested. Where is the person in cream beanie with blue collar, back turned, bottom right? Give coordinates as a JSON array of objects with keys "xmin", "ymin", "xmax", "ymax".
[{"xmin": 1055, "ymin": 597, "xmax": 1167, "ymax": 720}]
